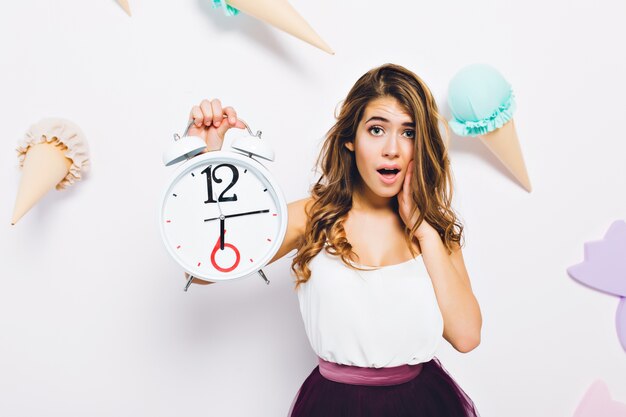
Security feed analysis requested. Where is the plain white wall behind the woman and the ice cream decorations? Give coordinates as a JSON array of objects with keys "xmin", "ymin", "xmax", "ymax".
[{"xmin": 0, "ymin": 0, "xmax": 626, "ymax": 417}]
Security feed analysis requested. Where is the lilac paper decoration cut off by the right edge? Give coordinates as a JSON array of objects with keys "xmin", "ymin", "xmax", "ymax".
[{"xmin": 567, "ymin": 220, "xmax": 626, "ymax": 350}]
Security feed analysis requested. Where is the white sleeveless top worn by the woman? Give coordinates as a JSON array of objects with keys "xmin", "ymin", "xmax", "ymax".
[{"xmin": 298, "ymin": 250, "xmax": 443, "ymax": 368}]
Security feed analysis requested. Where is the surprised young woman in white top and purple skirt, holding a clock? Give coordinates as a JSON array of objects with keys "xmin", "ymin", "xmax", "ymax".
[{"xmin": 184, "ymin": 64, "xmax": 482, "ymax": 417}]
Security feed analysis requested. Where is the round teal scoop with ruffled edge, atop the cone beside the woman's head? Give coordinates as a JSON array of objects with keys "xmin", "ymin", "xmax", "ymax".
[{"xmin": 448, "ymin": 64, "xmax": 515, "ymax": 136}]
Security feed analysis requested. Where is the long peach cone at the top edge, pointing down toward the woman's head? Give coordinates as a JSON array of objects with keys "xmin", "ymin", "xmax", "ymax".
[{"xmin": 213, "ymin": 0, "xmax": 335, "ymax": 55}]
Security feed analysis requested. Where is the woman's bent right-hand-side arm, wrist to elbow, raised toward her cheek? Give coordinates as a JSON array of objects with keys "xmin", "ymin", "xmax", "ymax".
[{"xmin": 416, "ymin": 227, "xmax": 482, "ymax": 353}]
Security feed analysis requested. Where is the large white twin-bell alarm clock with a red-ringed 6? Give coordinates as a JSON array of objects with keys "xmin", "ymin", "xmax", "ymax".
[{"xmin": 159, "ymin": 122, "xmax": 287, "ymax": 291}]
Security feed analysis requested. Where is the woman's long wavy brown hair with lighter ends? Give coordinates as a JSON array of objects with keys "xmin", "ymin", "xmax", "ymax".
[{"xmin": 291, "ymin": 64, "xmax": 463, "ymax": 288}]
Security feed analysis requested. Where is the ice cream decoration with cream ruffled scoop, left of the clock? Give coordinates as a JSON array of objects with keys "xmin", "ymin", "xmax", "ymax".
[{"xmin": 11, "ymin": 119, "xmax": 89, "ymax": 224}]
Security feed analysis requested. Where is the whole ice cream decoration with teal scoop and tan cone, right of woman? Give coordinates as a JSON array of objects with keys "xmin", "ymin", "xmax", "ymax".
[{"xmin": 448, "ymin": 64, "xmax": 532, "ymax": 192}]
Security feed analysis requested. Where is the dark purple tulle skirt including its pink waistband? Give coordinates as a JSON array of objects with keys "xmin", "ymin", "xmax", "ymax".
[{"xmin": 289, "ymin": 359, "xmax": 478, "ymax": 417}]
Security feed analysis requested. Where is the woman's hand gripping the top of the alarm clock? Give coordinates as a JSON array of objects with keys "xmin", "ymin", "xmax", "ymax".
[{"xmin": 187, "ymin": 99, "xmax": 245, "ymax": 151}]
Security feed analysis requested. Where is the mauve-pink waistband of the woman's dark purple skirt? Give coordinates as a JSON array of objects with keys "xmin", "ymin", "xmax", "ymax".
[{"xmin": 319, "ymin": 358, "xmax": 422, "ymax": 386}]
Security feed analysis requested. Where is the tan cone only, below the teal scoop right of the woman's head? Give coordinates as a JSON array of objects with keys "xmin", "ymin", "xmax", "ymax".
[{"xmin": 479, "ymin": 120, "xmax": 532, "ymax": 192}]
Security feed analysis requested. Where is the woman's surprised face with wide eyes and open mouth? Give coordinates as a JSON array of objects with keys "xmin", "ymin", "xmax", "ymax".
[{"xmin": 346, "ymin": 96, "xmax": 415, "ymax": 202}]
